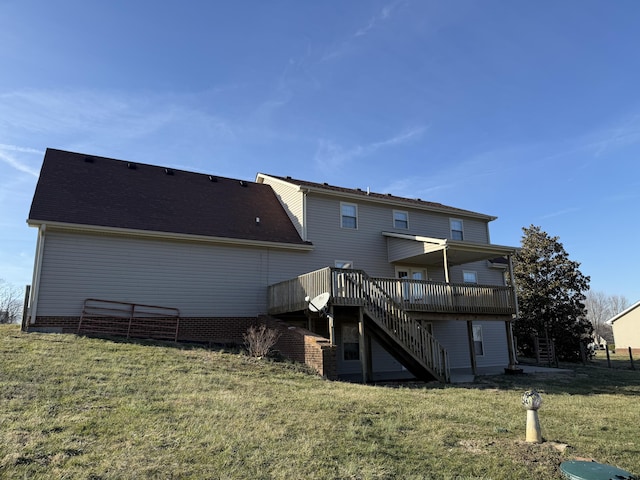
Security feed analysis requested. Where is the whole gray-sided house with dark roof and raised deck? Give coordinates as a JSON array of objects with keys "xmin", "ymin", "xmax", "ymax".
[{"xmin": 23, "ymin": 149, "xmax": 517, "ymax": 381}]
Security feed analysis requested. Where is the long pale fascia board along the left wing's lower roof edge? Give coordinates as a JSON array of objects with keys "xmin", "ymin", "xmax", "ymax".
[{"xmin": 27, "ymin": 219, "xmax": 314, "ymax": 252}]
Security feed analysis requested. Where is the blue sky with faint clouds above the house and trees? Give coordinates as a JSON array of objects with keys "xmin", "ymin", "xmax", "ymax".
[{"xmin": 0, "ymin": 0, "xmax": 640, "ymax": 302}]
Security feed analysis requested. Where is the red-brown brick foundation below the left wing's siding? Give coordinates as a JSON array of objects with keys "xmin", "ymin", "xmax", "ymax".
[{"xmin": 26, "ymin": 316, "xmax": 338, "ymax": 379}]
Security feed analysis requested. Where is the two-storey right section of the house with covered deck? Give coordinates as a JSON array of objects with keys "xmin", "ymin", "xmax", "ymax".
[{"xmin": 256, "ymin": 174, "xmax": 516, "ymax": 380}]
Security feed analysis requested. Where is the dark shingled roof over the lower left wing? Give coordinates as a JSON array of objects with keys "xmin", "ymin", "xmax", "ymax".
[{"xmin": 29, "ymin": 149, "xmax": 307, "ymax": 245}]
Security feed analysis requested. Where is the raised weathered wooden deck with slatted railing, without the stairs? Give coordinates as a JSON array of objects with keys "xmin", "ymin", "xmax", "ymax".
[{"xmin": 268, "ymin": 267, "xmax": 516, "ymax": 315}]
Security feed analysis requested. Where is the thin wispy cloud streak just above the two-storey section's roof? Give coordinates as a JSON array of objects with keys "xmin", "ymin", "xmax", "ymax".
[{"xmin": 315, "ymin": 126, "xmax": 428, "ymax": 168}]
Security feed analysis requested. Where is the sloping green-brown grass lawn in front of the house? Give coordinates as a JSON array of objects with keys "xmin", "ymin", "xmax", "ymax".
[{"xmin": 0, "ymin": 325, "xmax": 640, "ymax": 479}]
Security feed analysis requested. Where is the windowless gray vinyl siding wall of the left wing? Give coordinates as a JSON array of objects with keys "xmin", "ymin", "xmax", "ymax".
[{"xmin": 38, "ymin": 232, "xmax": 312, "ymax": 317}]
